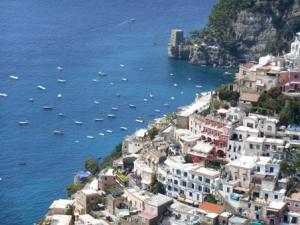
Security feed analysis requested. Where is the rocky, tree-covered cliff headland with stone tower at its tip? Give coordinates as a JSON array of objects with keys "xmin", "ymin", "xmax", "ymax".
[{"xmin": 169, "ymin": 0, "xmax": 300, "ymax": 66}]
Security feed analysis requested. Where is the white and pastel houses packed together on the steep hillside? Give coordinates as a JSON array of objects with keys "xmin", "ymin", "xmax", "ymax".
[{"xmin": 39, "ymin": 34, "xmax": 300, "ymax": 225}]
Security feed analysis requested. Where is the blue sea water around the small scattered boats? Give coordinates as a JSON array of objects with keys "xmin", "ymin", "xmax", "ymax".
[{"xmin": 0, "ymin": 0, "xmax": 232, "ymax": 225}]
